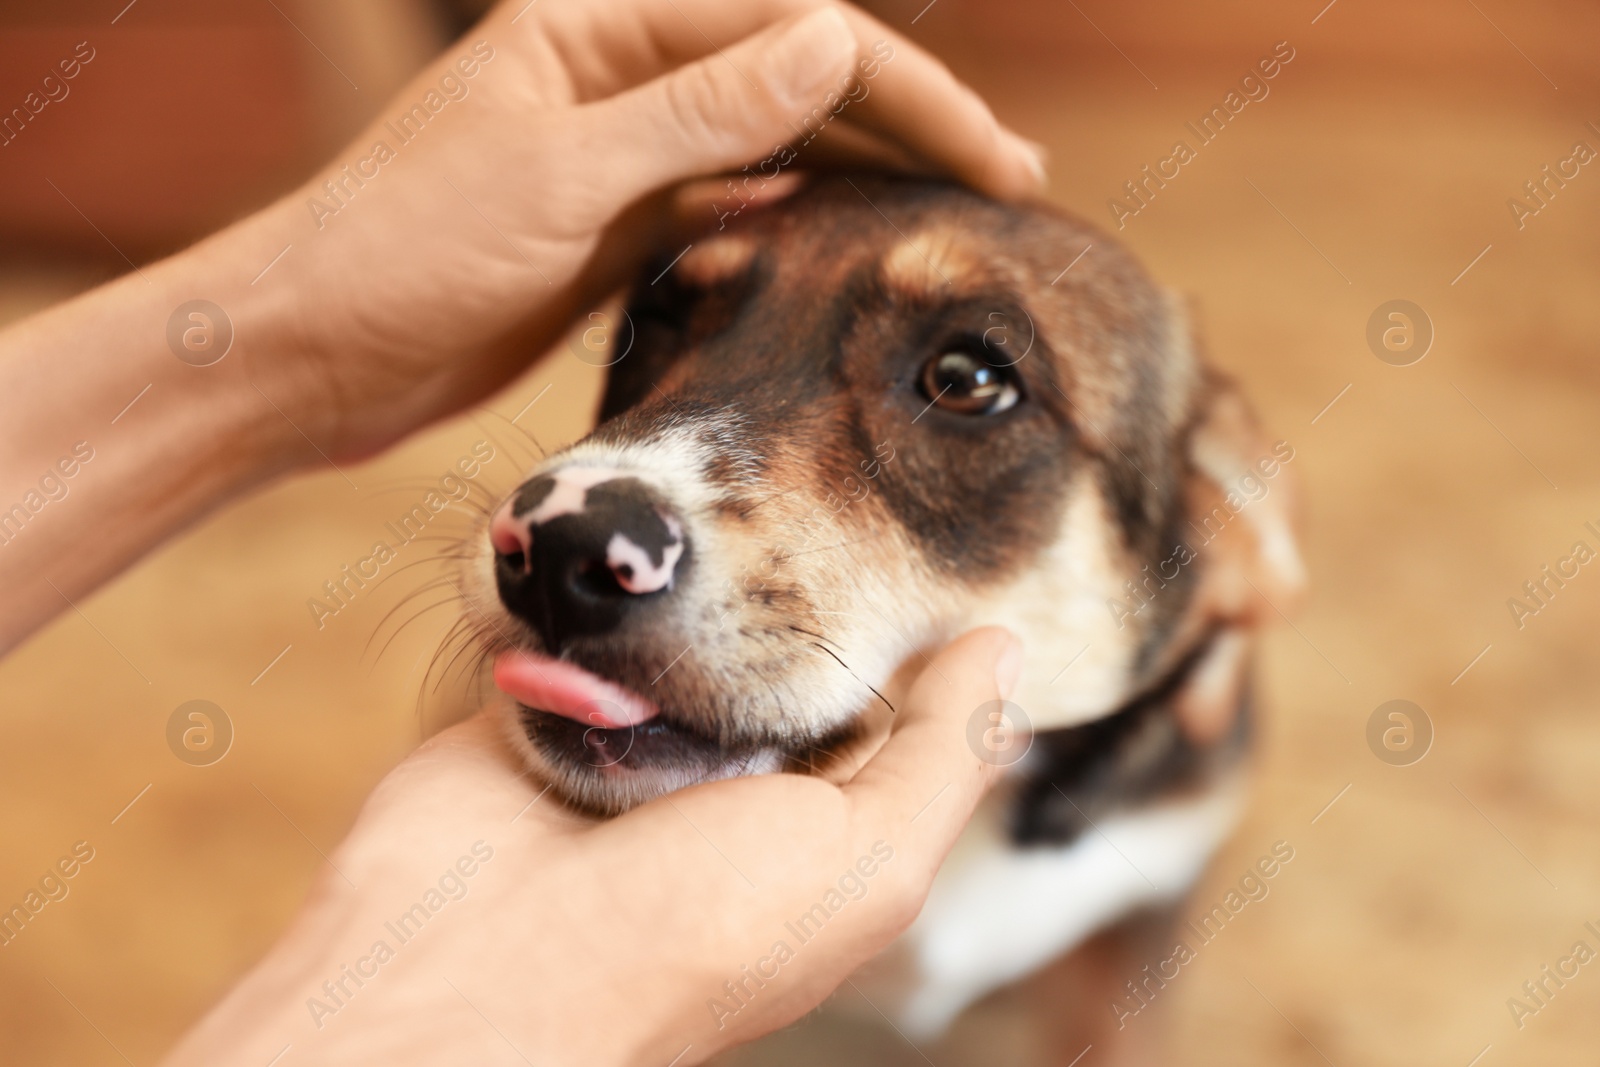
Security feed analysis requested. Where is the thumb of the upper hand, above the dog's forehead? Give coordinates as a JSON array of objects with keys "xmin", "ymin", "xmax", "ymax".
[{"xmin": 586, "ymin": 8, "xmax": 856, "ymax": 203}]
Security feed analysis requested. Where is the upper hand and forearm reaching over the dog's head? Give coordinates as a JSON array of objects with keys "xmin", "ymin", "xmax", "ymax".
[{"xmin": 0, "ymin": 0, "xmax": 1040, "ymax": 653}]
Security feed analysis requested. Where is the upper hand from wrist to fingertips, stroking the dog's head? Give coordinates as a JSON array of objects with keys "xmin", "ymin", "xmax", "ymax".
[{"xmin": 258, "ymin": 0, "xmax": 1042, "ymax": 459}]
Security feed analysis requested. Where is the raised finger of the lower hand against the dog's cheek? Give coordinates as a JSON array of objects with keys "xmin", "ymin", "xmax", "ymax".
[{"xmin": 845, "ymin": 627, "xmax": 1022, "ymax": 902}]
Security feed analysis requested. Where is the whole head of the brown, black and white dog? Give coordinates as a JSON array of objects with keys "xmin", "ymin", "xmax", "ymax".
[{"xmin": 470, "ymin": 178, "xmax": 1299, "ymax": 813}]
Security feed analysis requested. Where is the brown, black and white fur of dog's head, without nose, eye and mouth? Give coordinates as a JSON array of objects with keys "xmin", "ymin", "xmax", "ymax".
[{"xmin": 475, "ymin": 176, "xmax": 1301, "ymax": 1062}]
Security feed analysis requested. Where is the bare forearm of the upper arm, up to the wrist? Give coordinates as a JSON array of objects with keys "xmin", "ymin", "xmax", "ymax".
[{"xmin": 0, "ymin": 201, "xmax": 305, "ymax": 653}]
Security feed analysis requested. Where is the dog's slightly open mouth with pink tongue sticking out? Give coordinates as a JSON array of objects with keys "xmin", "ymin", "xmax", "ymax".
[{"xmin": 494, "ymin": 649, "xmax": 784, "ymax": 792}]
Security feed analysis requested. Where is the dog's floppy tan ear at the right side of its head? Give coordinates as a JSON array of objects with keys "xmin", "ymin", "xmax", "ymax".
[{"xmin": 1174, "ymin": 371, "xmax": 1306, "ymax": 744}]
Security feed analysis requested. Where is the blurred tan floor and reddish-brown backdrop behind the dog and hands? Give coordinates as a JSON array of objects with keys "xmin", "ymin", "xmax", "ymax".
[{"xmin": 0, "ymin": 0, "xmax": 1600, "ymax": 1067}]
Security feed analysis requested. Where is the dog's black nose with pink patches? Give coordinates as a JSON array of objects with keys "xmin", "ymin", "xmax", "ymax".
[{"xmin": 490, "ymin": 467, "xmax": 688, "ymax": 653}]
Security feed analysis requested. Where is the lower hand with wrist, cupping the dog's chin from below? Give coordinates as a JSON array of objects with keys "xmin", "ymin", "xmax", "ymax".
[{"xmin": 168, "ymin": 629, "xmax": 1021, "ymax": 1067}]
